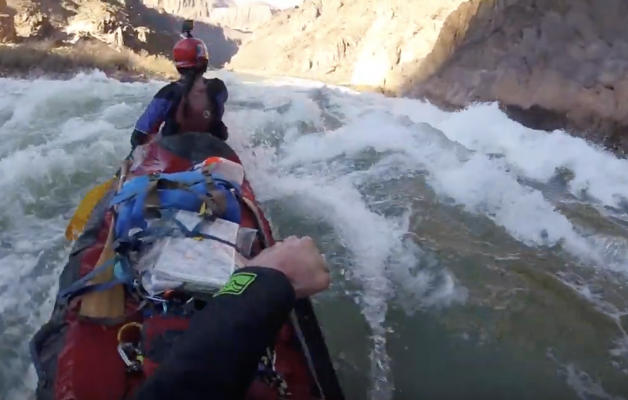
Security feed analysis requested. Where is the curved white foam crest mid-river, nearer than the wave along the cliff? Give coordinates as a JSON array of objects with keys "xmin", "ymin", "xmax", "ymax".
[{"xmin": 280, "ymin": 108, "xmax": 612, "ymax": 262}]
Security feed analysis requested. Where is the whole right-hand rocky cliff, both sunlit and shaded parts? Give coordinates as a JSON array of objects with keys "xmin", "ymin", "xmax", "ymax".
[{"xmin": 229, "ymin": 0, "xmax": 628, "ymax": 155}]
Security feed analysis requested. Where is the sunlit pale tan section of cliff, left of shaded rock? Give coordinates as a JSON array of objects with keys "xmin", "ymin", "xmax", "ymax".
[{"xmin": 230, "ymin": 0, "xmax": 476, "ymax": 88}]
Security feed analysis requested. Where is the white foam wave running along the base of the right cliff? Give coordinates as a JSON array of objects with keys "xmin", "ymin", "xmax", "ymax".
[{"xmin": 392, "ymin": 103, "xmax": 628, "ymax": 206}]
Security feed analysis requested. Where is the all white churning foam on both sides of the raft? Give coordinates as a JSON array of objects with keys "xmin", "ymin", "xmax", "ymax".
[{"xmin": 0, "ymin": 73, "xmax": 628, "ymax": 400}]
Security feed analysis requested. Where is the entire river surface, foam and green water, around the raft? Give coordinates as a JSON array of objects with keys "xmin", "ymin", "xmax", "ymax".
[{"xmin": 0, "ymin": 73, "xmax": 628, "ymax": 400}]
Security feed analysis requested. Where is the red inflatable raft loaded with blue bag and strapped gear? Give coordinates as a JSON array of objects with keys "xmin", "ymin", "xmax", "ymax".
[{"xmin": 31, "ymin": 133, "xmax": 344, "ymax": 400}]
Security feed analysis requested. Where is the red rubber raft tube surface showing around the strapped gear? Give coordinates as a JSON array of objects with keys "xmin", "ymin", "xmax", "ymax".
[{"xmin": 30, "ymin": 133, "xmax": 344, "ymax": 400}]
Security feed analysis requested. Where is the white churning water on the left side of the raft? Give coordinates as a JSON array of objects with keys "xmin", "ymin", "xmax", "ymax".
[{"xmin": 0, "ymin": 74, "xmax": 156, "ymax": 398}]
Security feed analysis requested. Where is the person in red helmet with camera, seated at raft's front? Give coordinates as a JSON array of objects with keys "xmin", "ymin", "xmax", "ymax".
[{"xmin": 131, "ymin": 21, "xmax": 229, "ymax": 149}]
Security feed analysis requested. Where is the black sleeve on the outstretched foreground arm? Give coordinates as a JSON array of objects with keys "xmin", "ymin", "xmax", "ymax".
[{"xmin": 133, "ymin": 267, "xmax": 295, "ymax": 400}]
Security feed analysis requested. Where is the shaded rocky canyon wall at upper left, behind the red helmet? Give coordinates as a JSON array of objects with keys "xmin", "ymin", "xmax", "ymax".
[{"xmin": 0, "ymin": 0, "xmax": 238, "ymax": 67}]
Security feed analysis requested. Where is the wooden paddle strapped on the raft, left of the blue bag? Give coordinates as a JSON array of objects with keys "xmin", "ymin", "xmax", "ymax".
[{"xmin": 79, "ymin": 160, "xmax": 130, "ymax": 318}]
